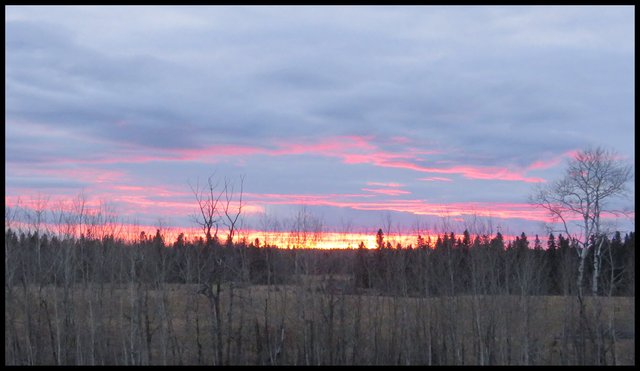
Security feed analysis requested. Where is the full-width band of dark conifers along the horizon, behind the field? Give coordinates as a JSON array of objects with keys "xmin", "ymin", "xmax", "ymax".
[{"xmin": 5, "ymin": 229, "xmax": 635, "ymax": 297}]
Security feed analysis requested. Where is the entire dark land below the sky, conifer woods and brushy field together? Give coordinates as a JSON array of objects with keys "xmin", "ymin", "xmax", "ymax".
[{"xmin": 5, "ymin": 229, "xmax": 635, "ymax": 365}]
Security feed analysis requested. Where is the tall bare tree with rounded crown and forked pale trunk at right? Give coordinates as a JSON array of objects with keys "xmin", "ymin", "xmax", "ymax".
[{"xmin": 529, "ymin": 147, "xmax": 633, "ymax": 296}]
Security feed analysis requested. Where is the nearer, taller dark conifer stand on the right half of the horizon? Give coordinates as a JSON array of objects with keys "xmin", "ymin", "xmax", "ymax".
[{"xmin": 353, "ymin": 230, "xmax": 635, "ymax": 297}]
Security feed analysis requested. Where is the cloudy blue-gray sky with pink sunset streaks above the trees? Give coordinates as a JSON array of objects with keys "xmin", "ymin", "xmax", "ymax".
[{"xmin": 5, "ymin": 6, "xmax": 635, "ymax": 244}]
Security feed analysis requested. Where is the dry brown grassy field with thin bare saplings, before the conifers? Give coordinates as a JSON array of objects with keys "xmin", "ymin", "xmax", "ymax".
[{"xmin": 5, "ymin": 276, "xmax": 635, "ymax": 365}]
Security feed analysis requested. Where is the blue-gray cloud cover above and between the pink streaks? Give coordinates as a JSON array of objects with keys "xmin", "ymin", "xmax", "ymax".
[{"xmin": 5, "ymin": 6, "xmax": 635, "ymax": 235}]
